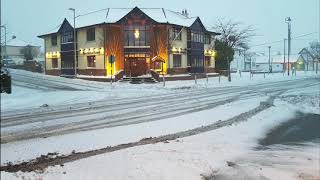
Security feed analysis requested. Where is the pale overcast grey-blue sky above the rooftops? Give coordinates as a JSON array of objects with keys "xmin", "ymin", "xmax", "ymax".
[{"xmin": 1, "ymin": 0, "xmax": 320, "ymax": 53}]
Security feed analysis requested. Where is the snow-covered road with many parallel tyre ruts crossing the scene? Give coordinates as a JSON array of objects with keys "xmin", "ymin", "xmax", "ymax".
[{"xmin": 1, "ymin": 76, "xmax": 319, "ymax": 143}]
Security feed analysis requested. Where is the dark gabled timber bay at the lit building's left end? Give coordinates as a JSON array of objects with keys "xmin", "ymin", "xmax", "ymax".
[{"xmin": 58, "ymin": 19, "xmax": 75, "ymax": 75}]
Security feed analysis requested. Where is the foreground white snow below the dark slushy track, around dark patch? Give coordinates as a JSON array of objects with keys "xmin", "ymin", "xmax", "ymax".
[{"xmin": 1, "ymin": 96, "xmax": 320, "ymax": 180}]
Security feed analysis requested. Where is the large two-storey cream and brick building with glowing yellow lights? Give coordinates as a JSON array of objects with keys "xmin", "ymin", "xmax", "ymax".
[{"xmin": 39, "ymin": 7, "xmax": 219, "ymax": 76}]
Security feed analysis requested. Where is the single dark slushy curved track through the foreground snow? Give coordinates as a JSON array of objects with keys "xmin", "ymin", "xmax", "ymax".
[{"xmin": 0, "ymin": 91, "xmax": 284, "ymax": 172}]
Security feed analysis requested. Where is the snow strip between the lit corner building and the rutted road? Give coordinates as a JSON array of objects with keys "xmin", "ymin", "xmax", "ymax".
[{"xmin": 1, "ymin": 69, "xmax": 319, "ymax": 111}]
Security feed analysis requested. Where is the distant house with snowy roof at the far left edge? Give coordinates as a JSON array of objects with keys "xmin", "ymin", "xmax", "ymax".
[{"xmin": 1, "ymin": 39, "xmax": 41, "ymax": 65}]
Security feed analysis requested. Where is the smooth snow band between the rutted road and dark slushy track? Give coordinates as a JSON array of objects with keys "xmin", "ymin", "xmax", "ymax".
[{"xmin": 1, "ymin": 97, "xmax": 266, "ymax": 165}]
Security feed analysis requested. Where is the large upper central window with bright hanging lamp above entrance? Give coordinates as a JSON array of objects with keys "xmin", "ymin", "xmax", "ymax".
[{"xmin": 124, "ymin": 25, "xmax": 150, "ymax": 46}]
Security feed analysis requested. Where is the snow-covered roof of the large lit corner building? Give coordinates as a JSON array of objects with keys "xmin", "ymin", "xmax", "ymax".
[{"xmin": 38, "ymin": 8, "xmax": 212, "ymax": 35}]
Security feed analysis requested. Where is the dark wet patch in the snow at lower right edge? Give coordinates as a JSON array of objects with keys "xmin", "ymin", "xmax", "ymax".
[{"xmin": 259, "ymin": 113, "xmax": 320, "ymax": 146}]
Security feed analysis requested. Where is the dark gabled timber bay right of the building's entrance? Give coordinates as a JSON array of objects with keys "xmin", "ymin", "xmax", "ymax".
[{"xmin": 188, "ymin": 18, "xmax": 206, "ymax": 73}]
